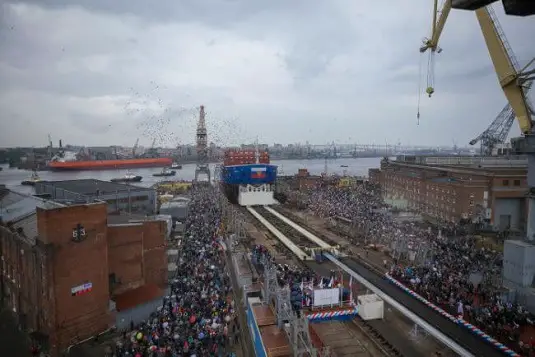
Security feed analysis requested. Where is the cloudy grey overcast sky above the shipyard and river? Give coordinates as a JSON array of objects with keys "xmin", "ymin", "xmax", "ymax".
[{"xmin": 0, "ymin": 0, "xmax": 535, "ymax": 147}]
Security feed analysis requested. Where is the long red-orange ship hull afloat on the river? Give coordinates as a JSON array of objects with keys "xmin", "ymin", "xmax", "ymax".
[{"xmin": 48, "ymin": 158, "xmax": 173, "ymax": 171}]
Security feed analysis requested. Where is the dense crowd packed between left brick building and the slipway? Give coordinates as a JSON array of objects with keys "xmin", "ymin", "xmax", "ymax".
[{"xmin": 110, "ymin": 187, "xmax": 239, "ymax": 357}]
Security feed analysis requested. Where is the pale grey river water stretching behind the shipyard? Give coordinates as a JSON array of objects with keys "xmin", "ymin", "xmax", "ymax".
[{"xmin": 0, "ymin": 158, "xmax": 381, "ymax": 194}]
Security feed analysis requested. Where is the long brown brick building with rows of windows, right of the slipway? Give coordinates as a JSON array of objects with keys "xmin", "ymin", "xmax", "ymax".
[{"xmin": 370, "ymin": 160, "xmax": 527, "ymax": 231}]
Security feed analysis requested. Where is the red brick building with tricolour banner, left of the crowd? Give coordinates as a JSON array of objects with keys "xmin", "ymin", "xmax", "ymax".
[{"xmin": 0, "ymin": 187, "xmax": 167, "ymax": 356}]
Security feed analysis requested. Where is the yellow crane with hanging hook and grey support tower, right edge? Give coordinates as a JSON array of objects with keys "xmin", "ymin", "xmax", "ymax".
[{"xmin": 420, "ymin": 0, "xmax": 535, "ymax": 236}]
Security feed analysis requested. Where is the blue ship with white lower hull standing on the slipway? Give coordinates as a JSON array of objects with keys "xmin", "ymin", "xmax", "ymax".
[{"xmin": 220, "ymin": 149, "xmax": 277, "ymax": 206}]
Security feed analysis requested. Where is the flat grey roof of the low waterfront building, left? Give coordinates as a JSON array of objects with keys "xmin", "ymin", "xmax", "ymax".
[{"xmin": 38, "ymin": 179, "xmax": 151, "ymax": 196}]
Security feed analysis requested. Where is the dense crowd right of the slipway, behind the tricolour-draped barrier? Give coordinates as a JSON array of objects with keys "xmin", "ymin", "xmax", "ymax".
[{"xmin": 307, "ymin": 185, "xmax": 535, "ymax": 355}]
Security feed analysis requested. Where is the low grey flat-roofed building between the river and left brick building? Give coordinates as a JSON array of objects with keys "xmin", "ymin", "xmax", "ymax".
[{"xmin": 35, "ymin": 179, "xmax": 157, "ymax": 215}]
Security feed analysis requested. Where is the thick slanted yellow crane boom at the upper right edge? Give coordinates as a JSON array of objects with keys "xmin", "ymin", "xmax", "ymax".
[{"xmin": 476, "ymin": 7, "xmax": 532, "ymax": 134}]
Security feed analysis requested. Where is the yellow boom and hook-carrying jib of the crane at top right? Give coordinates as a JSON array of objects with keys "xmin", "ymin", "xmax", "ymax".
[{"xmin": 420, "ymin": 0, "xmax": 535, "ymax": 135}]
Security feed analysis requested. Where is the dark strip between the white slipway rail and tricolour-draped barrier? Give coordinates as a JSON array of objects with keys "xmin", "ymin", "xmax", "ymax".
[{"xmin": 341, "ymin": 259, "xmax": 504, "ymax": 357}]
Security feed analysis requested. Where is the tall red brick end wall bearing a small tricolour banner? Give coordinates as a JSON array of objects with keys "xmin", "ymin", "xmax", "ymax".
[{"xmin": 37, "ymin": 204, "xmax": 112, "ymax": 350}]
